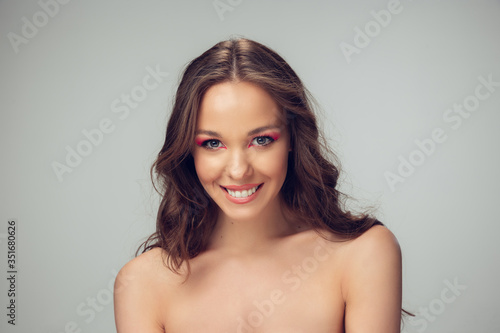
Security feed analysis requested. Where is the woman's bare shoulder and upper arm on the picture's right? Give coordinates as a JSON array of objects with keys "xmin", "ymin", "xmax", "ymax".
[{"xmin": 342, "ymin": 225, "xmax": 402, "ymax": 333}]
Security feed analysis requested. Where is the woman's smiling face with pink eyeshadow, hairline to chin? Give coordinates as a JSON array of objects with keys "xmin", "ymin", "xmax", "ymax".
[{"xmin": 192, "ymin": 82, "xmax": 290, "ymax": 220}]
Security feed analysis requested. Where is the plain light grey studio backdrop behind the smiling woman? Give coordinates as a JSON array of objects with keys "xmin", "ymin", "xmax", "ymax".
[{"xmin": 0, "ymin": 0, "xmax": 500, "ymax": 333}]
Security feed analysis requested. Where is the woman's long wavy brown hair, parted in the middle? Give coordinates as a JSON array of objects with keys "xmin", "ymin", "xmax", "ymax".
[{"xmin": 136, "ymin": 38, "xmax": 382, "ymax": 272}]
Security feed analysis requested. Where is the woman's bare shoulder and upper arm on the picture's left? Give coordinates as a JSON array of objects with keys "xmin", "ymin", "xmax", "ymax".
[{"xmin": 114, "ymin": 248, "xmax": 179, "ymax": 333}]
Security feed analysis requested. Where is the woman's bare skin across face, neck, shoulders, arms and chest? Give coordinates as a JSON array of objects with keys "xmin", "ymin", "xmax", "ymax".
[{"xmin": 115, "ymin": 82, "xmax": 402, "ymax": 333}]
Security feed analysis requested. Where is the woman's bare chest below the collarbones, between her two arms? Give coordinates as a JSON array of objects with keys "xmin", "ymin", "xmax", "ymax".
[{"xmin": 163, "ymin": 252, "xmax": 344, "ymax": 333}]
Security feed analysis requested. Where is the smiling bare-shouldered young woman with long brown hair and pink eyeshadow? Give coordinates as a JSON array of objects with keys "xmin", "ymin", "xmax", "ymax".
[{"xmin": 115, "ymin": 39, "xmax": 402, "ymax": 333}]
